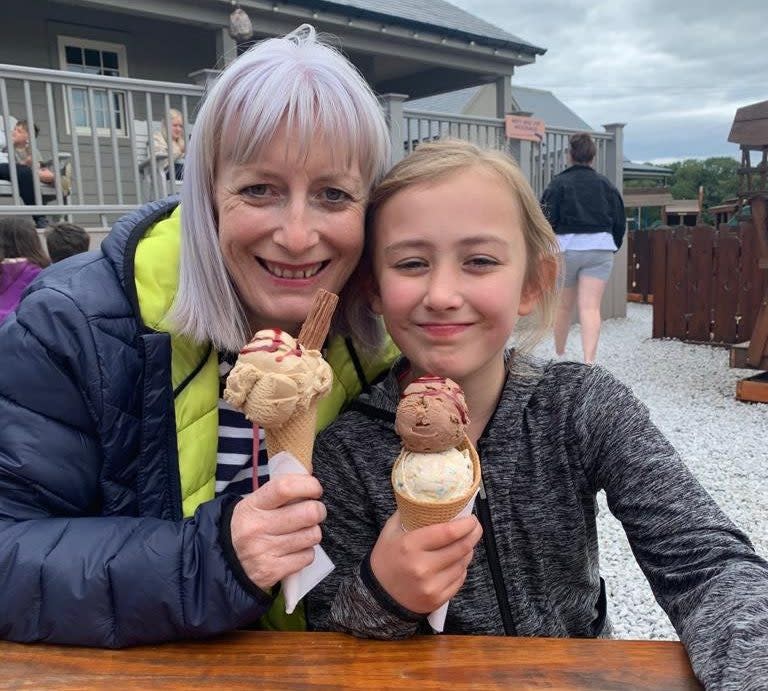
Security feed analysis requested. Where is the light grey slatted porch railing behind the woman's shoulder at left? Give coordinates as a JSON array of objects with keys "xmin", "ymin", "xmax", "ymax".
[{"xmin": 0, "ymin": 65, "xmax": 203, "ymax": 226}]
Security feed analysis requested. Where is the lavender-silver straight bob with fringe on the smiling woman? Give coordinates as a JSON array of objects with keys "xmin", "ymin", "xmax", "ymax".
[{"xmin": 171, "ymin": 24, "xmax": 390, "ymax": 351}]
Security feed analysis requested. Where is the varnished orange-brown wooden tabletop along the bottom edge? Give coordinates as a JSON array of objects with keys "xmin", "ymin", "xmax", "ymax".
[{"xmin": 0, "ymin": 631, "xmax": 701, "ymax": 691}]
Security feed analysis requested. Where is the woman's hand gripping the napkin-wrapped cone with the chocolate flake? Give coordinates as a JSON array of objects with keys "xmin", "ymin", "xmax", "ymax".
[{"xmin": 231, "ymin": 475, "xmax": 326, "ymax": 590}]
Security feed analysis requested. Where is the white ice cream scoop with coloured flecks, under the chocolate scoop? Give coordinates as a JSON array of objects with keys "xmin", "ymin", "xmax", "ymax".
[{"xmin": 392, "ymin": 449, "xmax": 473, "ymax": 503}]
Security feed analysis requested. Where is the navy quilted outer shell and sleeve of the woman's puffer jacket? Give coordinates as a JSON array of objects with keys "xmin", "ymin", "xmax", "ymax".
[{"xmin": 0, "ymin": 202, "xmax": 269, "ymax": 647}]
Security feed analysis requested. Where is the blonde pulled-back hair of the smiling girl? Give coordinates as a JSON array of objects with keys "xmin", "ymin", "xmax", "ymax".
[{"xmin": 348, "ymin": 139, "xmax": 560, "ymax": 349}]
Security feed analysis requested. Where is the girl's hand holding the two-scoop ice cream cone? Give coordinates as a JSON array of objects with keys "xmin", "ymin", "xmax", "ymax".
[{"xmin": 371, "ymin": 512, "xmax": 483, "ymax": 614}]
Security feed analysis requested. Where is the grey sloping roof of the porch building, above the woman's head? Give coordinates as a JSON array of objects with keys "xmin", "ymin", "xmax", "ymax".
[{"xmin": 306, "ymin": 0, "xmax": 546, "ymax": 55}]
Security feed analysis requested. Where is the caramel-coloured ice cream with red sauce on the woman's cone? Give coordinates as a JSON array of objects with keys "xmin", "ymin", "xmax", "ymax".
[{"xmin": 224, "ymin": 329, "xmax": 333, "ymax": 428}]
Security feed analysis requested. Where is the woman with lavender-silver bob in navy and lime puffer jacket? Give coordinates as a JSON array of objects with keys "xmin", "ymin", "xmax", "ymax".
[{"xmin": 0, "ymin": 26, "xmax": 393, "ymax": 647}]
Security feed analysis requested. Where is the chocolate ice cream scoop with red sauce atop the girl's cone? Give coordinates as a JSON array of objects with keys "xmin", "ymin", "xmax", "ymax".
[{"xmin": 395, "ymin": 376, "xmax": 469, "ymax": 452}]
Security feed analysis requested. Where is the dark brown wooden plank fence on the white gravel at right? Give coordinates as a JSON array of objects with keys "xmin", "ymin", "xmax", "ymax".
[{"xmin": 648, "ymin": 222, "xmax": 768, "ymax": 344}]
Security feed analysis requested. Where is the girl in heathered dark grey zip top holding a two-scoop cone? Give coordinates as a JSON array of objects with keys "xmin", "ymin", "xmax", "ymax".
[{"xmin": 308, "ymin": 141, "xmax": 768, "ymax": 686}]
